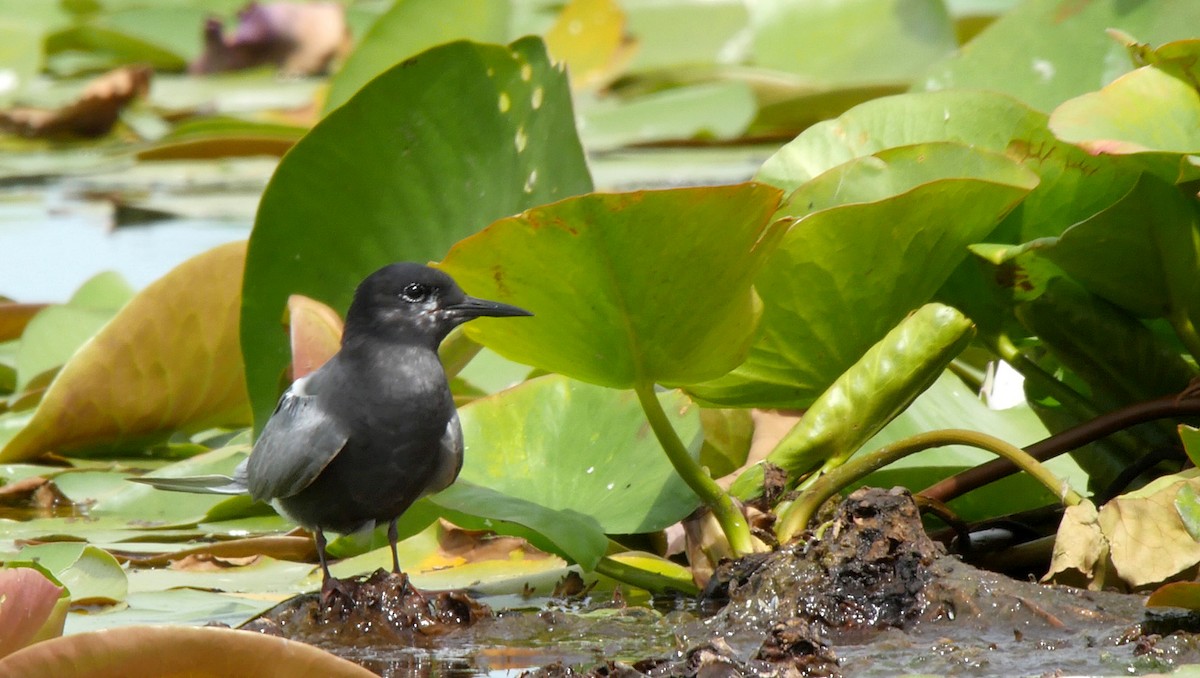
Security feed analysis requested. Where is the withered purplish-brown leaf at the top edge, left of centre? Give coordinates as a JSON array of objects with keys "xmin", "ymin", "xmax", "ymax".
[{"xmin": 188, "ymin": 2, "xmax": 350, "ymax": 76}]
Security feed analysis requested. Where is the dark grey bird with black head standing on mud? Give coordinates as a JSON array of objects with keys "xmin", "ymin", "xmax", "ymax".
[{"xmin": 131, "ymin": 262, "xmax": 533, "ymax": 594}]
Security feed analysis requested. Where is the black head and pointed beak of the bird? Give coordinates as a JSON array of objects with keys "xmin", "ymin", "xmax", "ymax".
[{"xmin": 344, "ymin": 262, "xmax": 533, "ymax": 347}]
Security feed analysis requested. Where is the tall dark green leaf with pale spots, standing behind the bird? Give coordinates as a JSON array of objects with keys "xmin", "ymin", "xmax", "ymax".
[{"xmin": 241, "ymin": 38, "xmax": 592, "ymax": 426}]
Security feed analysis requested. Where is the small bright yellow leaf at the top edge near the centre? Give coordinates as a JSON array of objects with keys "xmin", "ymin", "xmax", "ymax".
[{"xmin": 546, "ymin": 0, "xmax": 634, "ymax": 89}]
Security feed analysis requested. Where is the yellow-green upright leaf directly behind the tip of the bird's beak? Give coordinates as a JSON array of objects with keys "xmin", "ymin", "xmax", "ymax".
[{"xmin": 442, "ymin": 184, "xmax": 786, "ymax": 388}]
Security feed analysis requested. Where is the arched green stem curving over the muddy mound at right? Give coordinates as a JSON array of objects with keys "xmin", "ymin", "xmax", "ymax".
[{"xmin": 775, "ymin": 428, "xmax": 1084, "ymax": 544}]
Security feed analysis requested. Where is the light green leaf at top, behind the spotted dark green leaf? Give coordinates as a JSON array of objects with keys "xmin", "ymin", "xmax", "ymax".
[{"xmin": 325, "ymin": 0, "xmax": 512, "ymax": 114}]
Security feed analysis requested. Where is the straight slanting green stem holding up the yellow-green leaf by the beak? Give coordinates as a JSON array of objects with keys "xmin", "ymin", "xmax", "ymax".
[{"xmin": 634, "ymin": 383, "xmax": 754, "ymax": 556}]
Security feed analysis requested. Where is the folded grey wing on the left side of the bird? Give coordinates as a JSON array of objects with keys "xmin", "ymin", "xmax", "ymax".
[{"xmin": 246, "ymin": 379, "xmax": 349, "ymax": 502}]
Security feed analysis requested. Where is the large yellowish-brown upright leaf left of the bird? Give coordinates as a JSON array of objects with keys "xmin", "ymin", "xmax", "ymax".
[{"xmin": 0, "ymin": 242, "xmax": 250, "ymax": 462}]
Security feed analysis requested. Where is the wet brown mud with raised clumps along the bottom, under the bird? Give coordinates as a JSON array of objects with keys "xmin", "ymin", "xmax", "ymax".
[{"xmin": 236, "ymin": 488, "xmax": 1200, "ymax": 677}]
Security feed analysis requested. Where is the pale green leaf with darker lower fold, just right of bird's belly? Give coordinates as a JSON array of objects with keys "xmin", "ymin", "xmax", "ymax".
[{"xmin": 433, "ymin": 376, "xmax": 703, "ymax": 568}]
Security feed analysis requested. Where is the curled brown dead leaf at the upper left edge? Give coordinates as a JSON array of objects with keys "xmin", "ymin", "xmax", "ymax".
[{"xmin": 0, "ymin": 66, "xmax": 154, "ymax": 138}]
